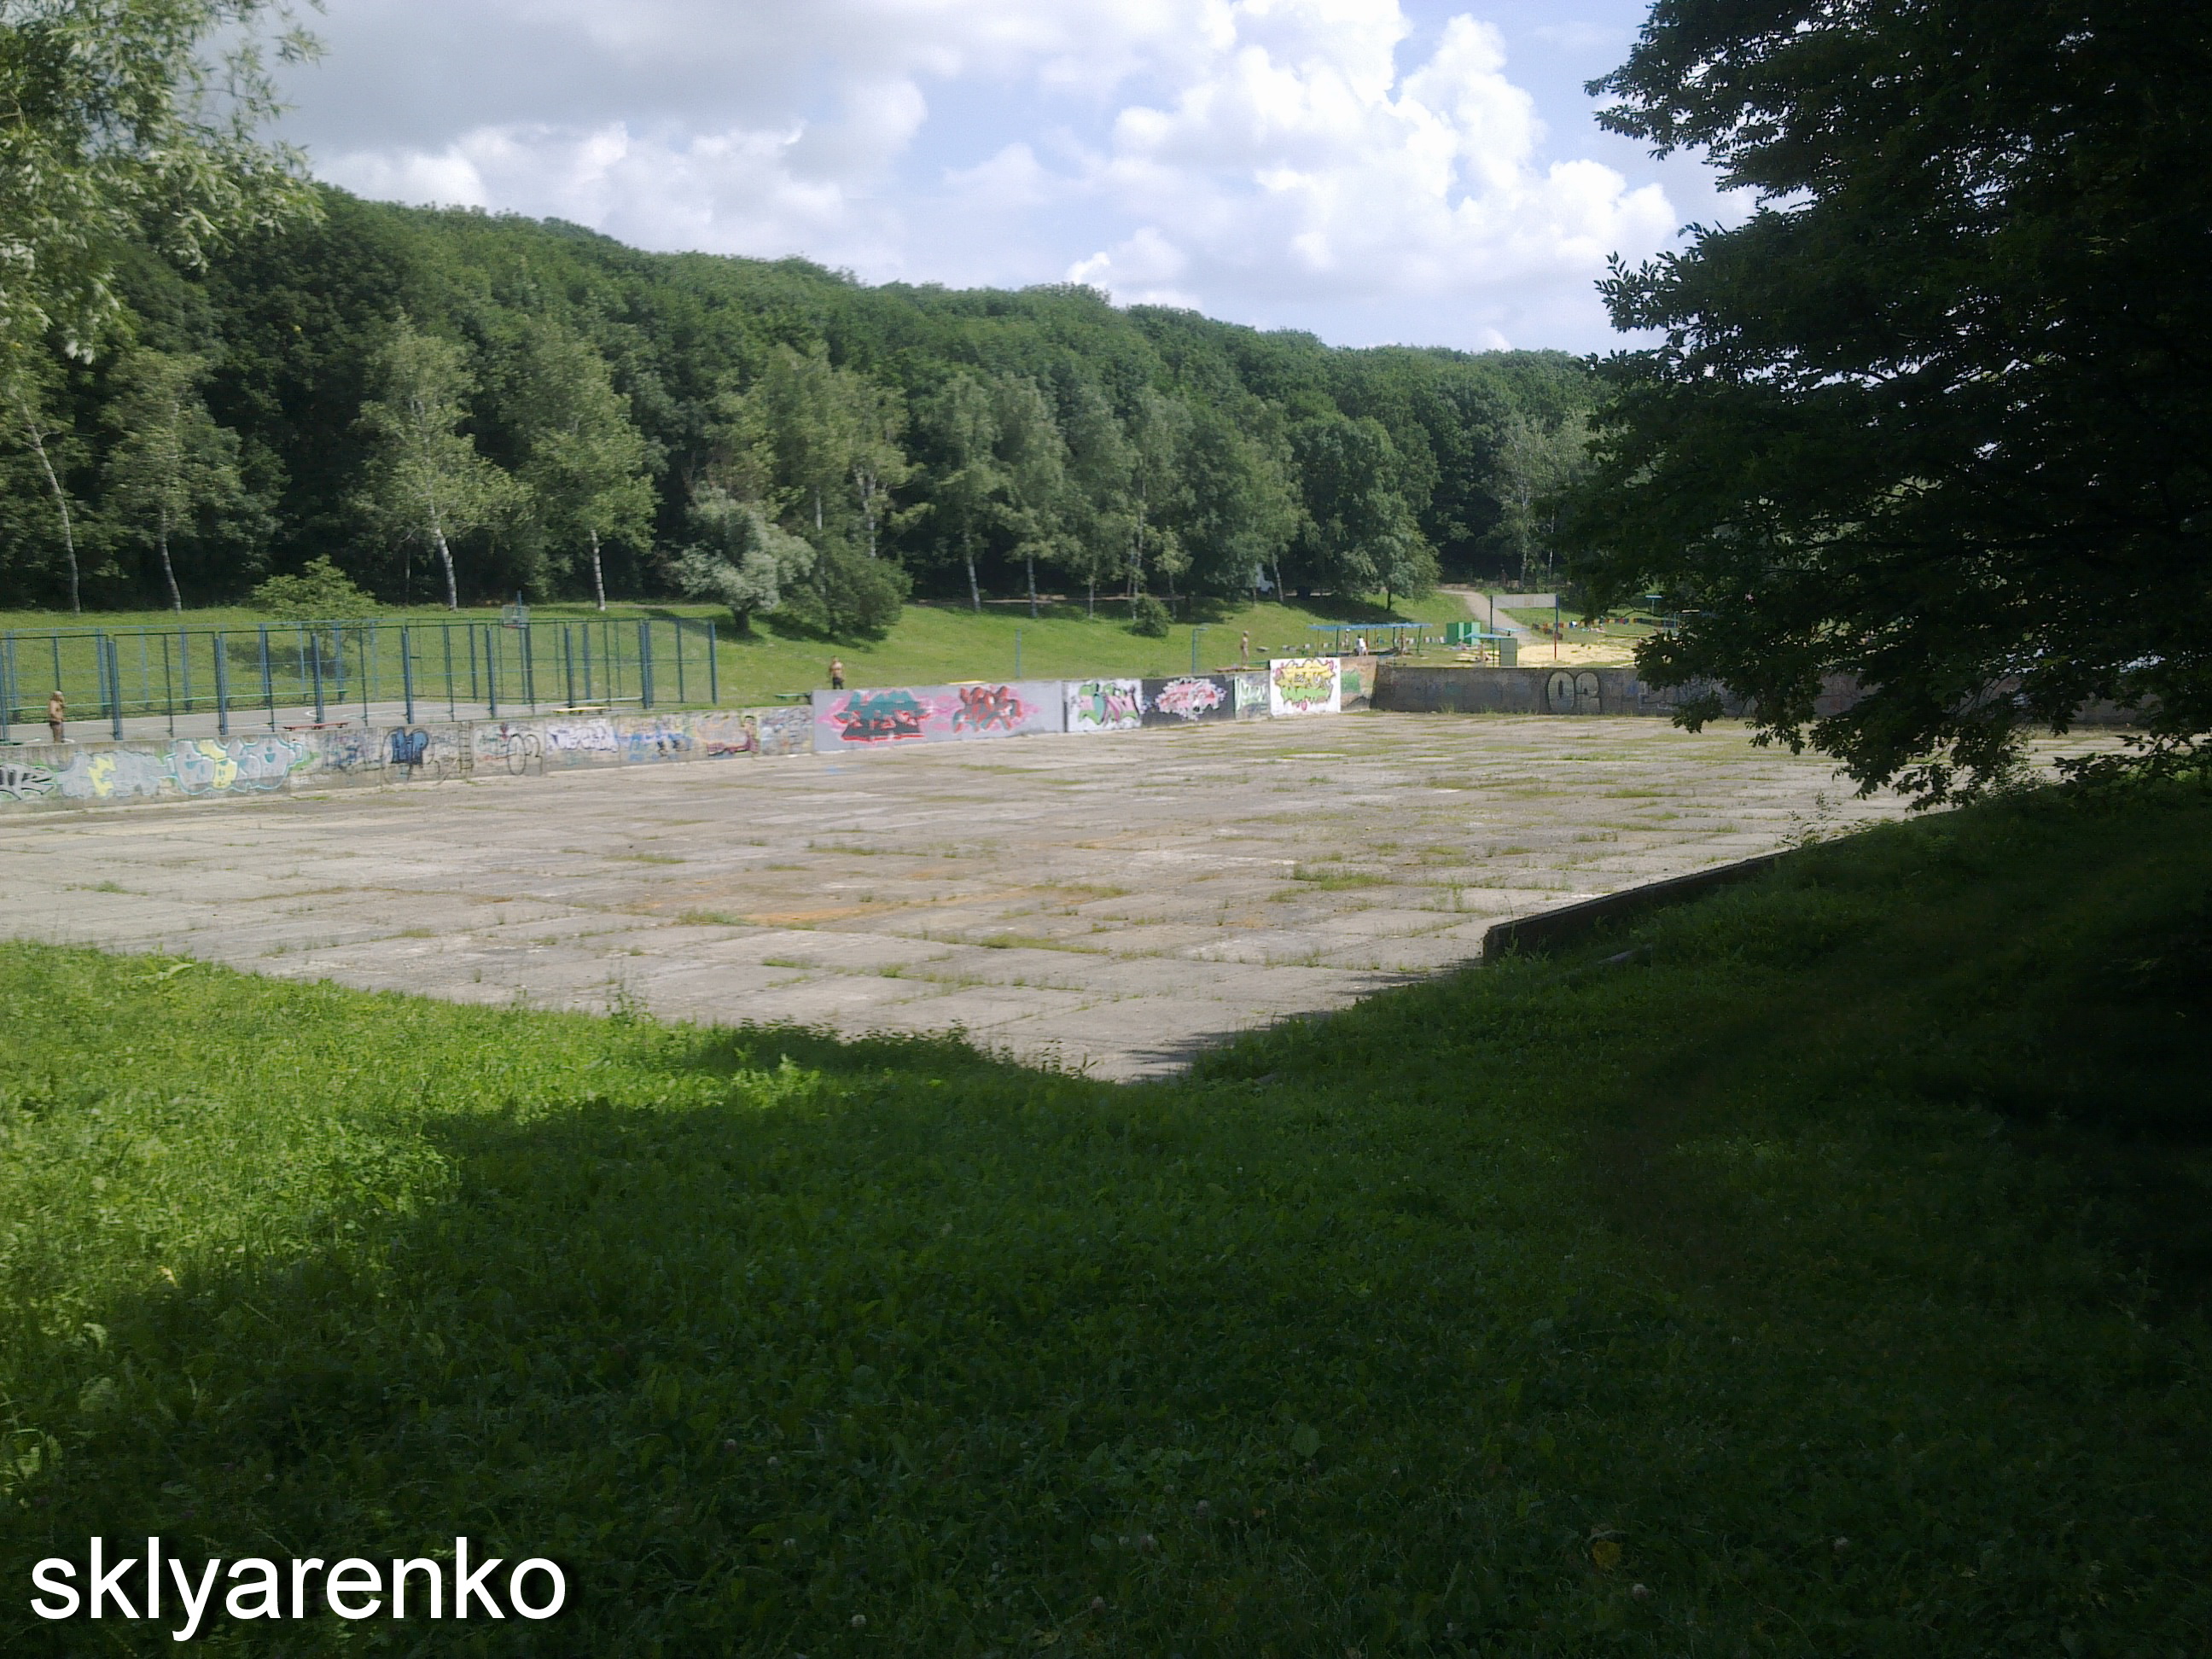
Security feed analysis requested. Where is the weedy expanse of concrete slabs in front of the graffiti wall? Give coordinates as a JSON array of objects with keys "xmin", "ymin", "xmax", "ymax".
[{"xmin": 0, "ymin": 714, "xmax": 2026, "ymax": 1077}]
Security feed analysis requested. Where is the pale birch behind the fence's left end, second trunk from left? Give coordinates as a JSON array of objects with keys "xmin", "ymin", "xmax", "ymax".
[{"xmin": 104, "ymin": 347, "xmax": 246, "ymax": 610}]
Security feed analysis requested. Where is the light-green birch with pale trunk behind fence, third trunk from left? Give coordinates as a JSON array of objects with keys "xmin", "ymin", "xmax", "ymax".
[{"xmin": 358, "ymin": 317, "xmax": 524, "ymax": 610}]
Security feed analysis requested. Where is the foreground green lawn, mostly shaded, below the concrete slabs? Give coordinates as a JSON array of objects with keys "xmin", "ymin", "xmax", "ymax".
[{"xmin": 0, "ymin": 795, "xmax": 2212, "ymax": 1659}]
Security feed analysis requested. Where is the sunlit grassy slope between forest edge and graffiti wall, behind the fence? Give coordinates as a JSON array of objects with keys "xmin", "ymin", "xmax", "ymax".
[{"xmin": 0, "ymin": 593, "xmax": 1466, "ymax": 719}]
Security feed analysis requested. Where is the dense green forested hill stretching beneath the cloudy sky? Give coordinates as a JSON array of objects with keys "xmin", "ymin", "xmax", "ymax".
[{"xmin": 0, "ymin": 190, "xmax": 1591, "ymax": 624}]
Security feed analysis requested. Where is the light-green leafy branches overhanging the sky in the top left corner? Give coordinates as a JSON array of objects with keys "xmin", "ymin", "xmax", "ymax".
[{"xmin": 0, "ymin": 0, "xmax": 317, "ymax": 356}]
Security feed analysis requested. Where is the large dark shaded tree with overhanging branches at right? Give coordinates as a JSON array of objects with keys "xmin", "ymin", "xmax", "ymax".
[{"xmin": 1570, "ymin": 0, "xmax": 2212, "ymax": 799}]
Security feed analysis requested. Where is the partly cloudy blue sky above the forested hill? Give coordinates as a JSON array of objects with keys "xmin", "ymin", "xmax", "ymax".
[{"xmin": 283, "ymin": 0, "xmax": 1734, "ymax": 352}]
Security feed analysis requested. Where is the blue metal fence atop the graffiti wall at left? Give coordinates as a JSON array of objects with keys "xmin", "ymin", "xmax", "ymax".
[{"xmin": 0, "ymin": 617, "xmax": 721, "ymax": 739}]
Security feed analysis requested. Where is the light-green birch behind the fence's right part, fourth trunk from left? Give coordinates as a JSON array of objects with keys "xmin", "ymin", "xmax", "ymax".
[{"xmin": 518, "ymin": 321, "xmax": 655, "ymax": 610}]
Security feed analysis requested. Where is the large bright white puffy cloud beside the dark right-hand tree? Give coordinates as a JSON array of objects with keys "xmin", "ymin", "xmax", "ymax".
[{"xmin": 1073, "ymin": 0, "xmax": 1674, "ymax": 345}]
